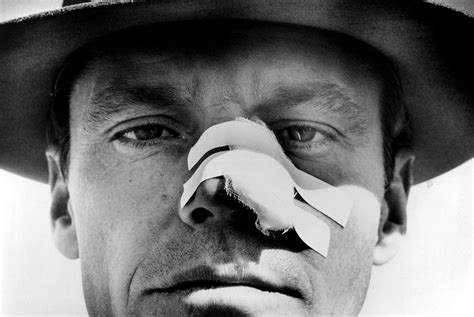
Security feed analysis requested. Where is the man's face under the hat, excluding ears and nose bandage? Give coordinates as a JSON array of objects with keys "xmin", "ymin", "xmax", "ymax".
[{"xmin": 59, "ymin": 26, "xmax": 392, "ymax": 316}]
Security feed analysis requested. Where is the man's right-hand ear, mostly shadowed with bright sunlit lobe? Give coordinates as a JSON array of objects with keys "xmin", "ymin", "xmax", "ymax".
[{"xmin": 373, "ymin": 149, "xmax": 415, "ymax": 265}]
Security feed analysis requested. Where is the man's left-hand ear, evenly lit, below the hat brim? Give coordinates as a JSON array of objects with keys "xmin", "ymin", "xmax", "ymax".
[{"xmin": 46, "ymin": 151, "xmax": 79, "ymax": 259}]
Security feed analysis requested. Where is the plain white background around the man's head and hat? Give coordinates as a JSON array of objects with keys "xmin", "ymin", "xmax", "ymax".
[{"xmin": 0, "ymin": 0, "xmax": 474, "ymax": 316}]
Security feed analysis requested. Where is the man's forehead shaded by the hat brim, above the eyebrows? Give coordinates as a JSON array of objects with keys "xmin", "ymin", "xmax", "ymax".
[{"xmin": 74, "ymin": 22, "xmax": 380, "ymax": 102}]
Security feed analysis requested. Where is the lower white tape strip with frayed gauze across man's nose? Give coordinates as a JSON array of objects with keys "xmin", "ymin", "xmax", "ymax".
[{"xmin": 181, "ymin": 149, "xmax": 330, "ymax": 257}]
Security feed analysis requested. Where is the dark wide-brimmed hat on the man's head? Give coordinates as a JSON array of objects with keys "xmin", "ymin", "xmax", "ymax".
[{"xmin": 0, "ymin": 0, "xmax": 474, "ymax": 183}]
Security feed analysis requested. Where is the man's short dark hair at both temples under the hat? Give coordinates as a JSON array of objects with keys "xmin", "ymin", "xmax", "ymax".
[{"xmin": 47, "ymin": 21, "xmax": 411, "ymax": 188}]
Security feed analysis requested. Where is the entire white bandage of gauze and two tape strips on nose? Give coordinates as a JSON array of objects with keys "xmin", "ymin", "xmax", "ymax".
[{"xmin": 181, "ymin": 118, "xmax": 352, "ymax": 257}]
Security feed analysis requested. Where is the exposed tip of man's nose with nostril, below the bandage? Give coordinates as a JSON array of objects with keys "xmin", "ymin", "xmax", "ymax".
[{"xmin": 179, "ymin": 176, "xmax": 255, "ymax": 229}]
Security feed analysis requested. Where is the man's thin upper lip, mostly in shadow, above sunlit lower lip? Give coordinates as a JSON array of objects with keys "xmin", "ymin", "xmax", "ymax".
[{"xmin": 147, "ymin": 266, "xmax": 303, "ymax": 298}]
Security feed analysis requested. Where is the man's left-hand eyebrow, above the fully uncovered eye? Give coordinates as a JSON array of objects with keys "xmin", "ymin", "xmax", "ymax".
[{"xmin": 84, "ymin": 82, "xmax": 193, "ymax": 131}]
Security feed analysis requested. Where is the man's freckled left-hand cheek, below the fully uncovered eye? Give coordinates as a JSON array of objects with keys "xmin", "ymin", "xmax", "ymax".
[{"xmin": 70, "ymin": 151, "xmax": 186, "ymax": 307}]
